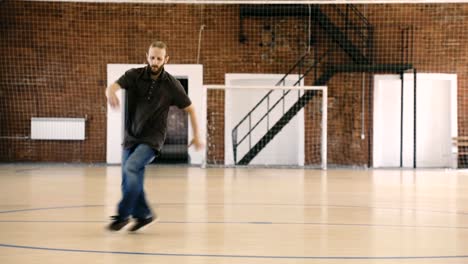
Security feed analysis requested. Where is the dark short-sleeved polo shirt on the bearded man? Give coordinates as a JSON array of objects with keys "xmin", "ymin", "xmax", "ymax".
[{"xmin": 117, "ymin": 66, "xmax": 191, "ymax": 151}]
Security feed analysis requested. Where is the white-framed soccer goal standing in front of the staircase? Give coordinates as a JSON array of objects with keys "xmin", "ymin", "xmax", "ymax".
[{"xmin": 206, "ymin": 85, "xmax": 327, "ymax": 169}]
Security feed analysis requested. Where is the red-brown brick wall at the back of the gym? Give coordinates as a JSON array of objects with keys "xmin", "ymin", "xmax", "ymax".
[{"xmin": 0, "ymin": 1, "xmax": 468, "ymax": 165}]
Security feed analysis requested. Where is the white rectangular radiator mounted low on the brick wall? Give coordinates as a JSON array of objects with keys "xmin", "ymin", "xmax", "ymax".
[{"xmin": 31, "ymin": 117, "xmax": 86, "ymax": 140}]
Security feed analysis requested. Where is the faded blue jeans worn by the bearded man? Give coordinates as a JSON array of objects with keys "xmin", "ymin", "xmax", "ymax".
[{"xmin": 118, "ymin": 144, "xmax": 156, "ymax": 219}]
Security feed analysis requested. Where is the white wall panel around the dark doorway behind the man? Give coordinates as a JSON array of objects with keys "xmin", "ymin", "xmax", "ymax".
[{"xmin": 106, "ymin": 64, "xmax": 206, "ymax": 164}]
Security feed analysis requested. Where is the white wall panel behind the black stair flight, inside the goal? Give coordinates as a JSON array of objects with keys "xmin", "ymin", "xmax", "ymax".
[{"xmin": 224, "ymin": 74, "xmax": 304, "ymax": 166}]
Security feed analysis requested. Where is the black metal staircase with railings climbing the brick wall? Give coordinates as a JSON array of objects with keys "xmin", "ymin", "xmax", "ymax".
[{"xmin": 232, "ymin": 4, "xmax": 413, "ymax": 165}]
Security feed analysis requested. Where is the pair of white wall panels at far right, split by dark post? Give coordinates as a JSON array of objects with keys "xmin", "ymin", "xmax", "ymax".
[{"xmin": 373, "ymin": 73, "xmax": 458, "ymax": 168}]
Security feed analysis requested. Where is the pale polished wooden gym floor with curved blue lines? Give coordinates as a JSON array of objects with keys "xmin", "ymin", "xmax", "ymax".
[{"xmin": 0, "ymin": 164, "xmax": 468, "ymax": 264}]
